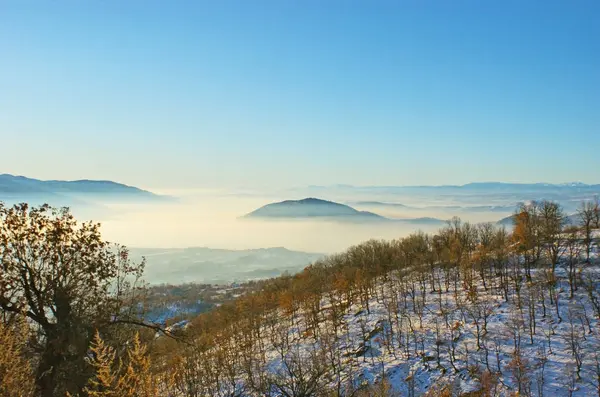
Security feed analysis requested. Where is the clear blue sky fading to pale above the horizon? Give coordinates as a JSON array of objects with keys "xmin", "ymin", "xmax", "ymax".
[{"xmin": 0, "ymin": 0, "xmax": 600, "ymax": 187}]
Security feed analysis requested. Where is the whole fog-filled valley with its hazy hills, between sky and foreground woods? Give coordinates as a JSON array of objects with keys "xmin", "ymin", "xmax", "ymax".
[{"xmin": 0, "ymin": 175, "xmax": 600, "ymax": 284}]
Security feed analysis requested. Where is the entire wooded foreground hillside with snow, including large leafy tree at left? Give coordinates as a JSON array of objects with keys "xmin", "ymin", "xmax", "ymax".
[{"xmin": 0, "ymin": 201, "xmax": 600, "ymax": 397}]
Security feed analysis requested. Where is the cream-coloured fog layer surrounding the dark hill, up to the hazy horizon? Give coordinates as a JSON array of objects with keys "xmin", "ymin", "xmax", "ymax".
[{"xmin": 0, "ymin": 174, "xmax": 600, "ymax": 254}]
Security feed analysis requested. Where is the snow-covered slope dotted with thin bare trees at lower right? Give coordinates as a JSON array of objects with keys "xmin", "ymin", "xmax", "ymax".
[{"xmin": 172, "ymin": 234, "xmax": 600, "ymax": 396}]
